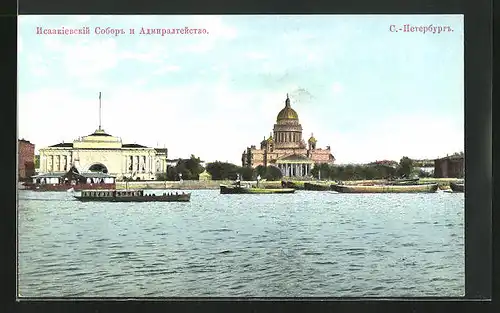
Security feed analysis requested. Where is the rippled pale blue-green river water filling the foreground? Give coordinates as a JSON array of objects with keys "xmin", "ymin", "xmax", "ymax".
[{"xmin": 18, "ymin": 190, "xmax": 465, "ymax": 297}]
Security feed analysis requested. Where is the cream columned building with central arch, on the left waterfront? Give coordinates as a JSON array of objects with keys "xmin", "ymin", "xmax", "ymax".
[{"xmin": 40, "ymin": 126, "xmax": 168, "ymax": 180}]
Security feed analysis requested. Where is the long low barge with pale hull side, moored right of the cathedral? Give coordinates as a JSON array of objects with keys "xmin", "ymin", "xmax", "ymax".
[{"xmin": 331, "ymin": 184, "xmax": 438, "ymax": 193}]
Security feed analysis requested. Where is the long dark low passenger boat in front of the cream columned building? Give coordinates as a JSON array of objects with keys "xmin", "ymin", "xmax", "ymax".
[{"xmin": 74, "ymin": 189, "xmax": 191, "ymax": 202}]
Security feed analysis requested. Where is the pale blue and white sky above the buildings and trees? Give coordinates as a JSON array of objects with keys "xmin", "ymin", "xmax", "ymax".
[{"xmin": 18, "ymin": 15, "xmax": 464, "ymax": 164}]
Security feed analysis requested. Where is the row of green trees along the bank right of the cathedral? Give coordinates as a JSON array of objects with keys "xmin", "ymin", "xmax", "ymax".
[{"xmin": 311, "ymin": 157, "xmax": 432, "ymax": 180}]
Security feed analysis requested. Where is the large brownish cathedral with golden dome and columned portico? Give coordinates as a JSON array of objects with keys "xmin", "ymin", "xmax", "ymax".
[{"xmin": 242, "ymin": 95, "xmax": 335, "ymax": 177}]
